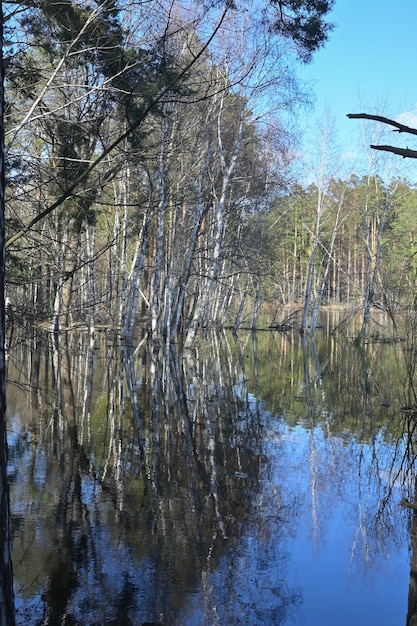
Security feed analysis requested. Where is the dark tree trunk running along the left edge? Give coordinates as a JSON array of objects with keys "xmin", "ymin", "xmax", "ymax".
[{"xmin": 0, "ymin": 2, "xmax": 15, "ymax": 626}]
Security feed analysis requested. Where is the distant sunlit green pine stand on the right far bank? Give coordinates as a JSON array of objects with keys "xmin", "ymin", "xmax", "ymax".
[{"xmin": 263, "ymin": 174, "xmax": 417, "ymax": 329}]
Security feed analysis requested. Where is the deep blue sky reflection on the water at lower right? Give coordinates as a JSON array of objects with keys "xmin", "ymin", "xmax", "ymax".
[{"xmin": 174, "ymin": 412, "xmax": 410, "ymax": 626}]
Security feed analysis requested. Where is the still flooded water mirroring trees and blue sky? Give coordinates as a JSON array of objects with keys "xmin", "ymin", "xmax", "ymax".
[{"xmin": 4, "ymin": 320, "xmax": 417, "ymax": 626}]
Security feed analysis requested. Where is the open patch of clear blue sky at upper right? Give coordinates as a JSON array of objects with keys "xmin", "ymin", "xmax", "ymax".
[{"xmin": 300, "ymin": 0, "xmax": 417, "ymax": 178}]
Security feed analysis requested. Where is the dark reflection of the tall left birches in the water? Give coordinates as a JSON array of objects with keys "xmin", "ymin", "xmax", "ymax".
[{"xmin": 9, "ymin": 335, "xmax": 298, "ymax": 624}]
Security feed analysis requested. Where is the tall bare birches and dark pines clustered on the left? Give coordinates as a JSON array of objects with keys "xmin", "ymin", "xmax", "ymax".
[{"xmin": 5, "ymin": 0, "xmax": 338, "ymax": 344}]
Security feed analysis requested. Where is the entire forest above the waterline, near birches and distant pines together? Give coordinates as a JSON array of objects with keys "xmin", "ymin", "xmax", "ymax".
[{"xmin": 4, "ymin": 1, "xmax": 416, "ymax": 345}]
